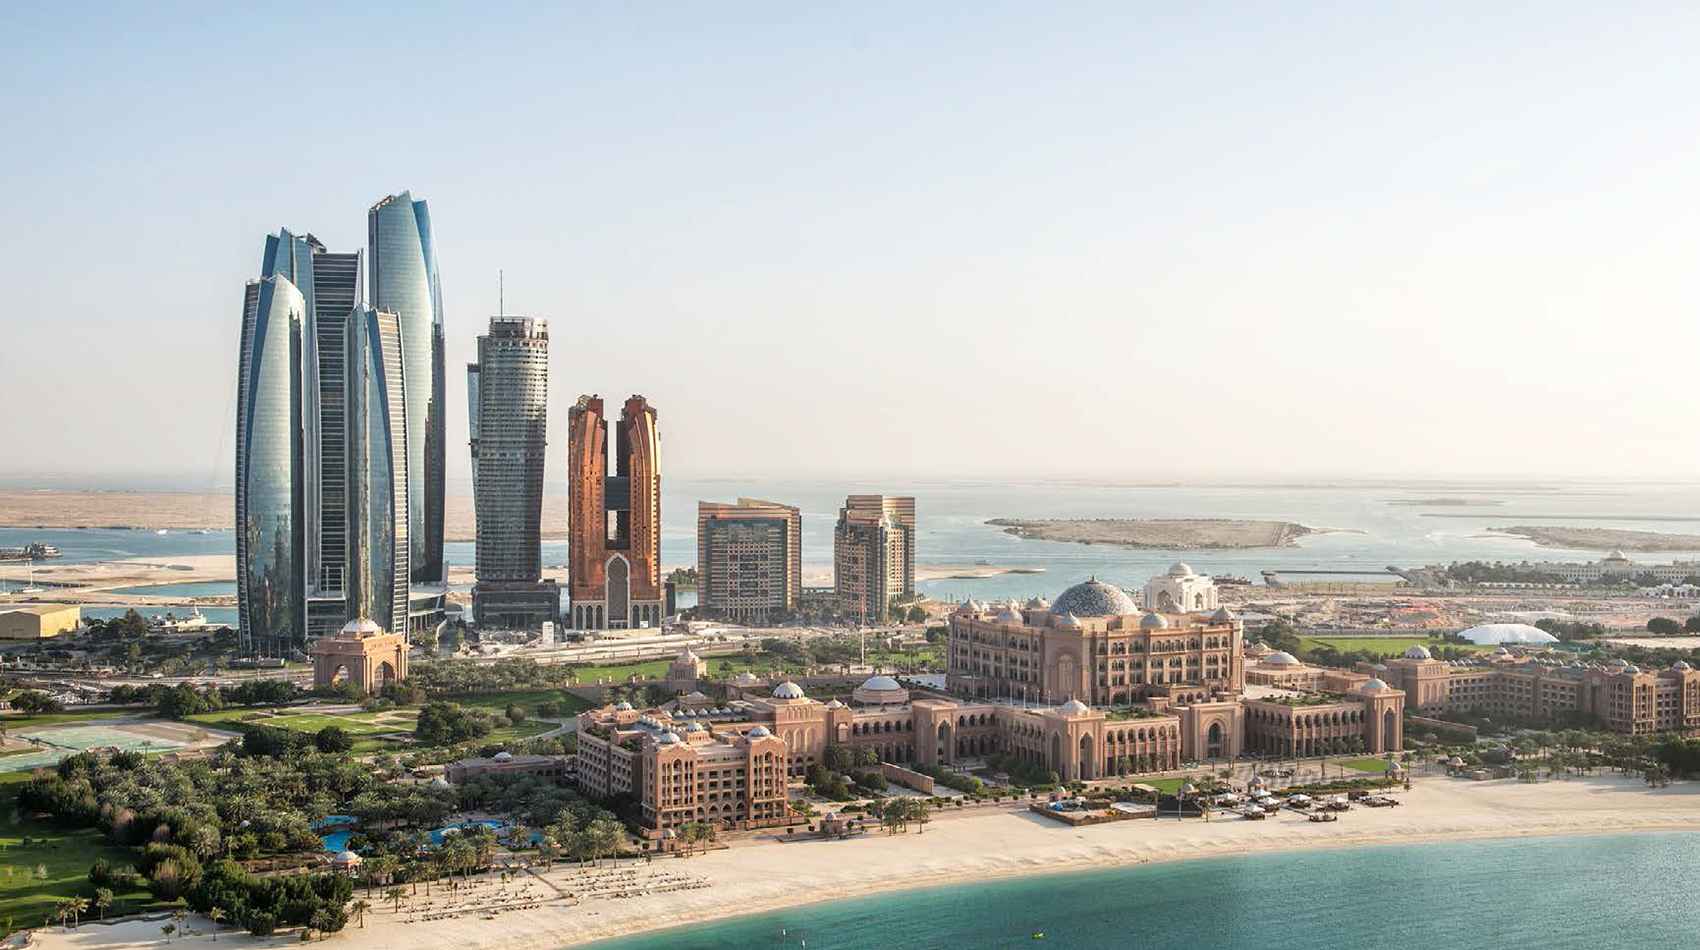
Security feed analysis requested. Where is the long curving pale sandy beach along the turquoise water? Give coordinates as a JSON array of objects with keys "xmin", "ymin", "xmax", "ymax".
[{"xmin": 37, "ymin": 777, "xmax": 1700, "ymax": 950}]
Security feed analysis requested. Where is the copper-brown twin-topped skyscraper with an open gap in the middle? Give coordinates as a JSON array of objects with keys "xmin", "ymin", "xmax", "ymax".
[{"xmin": 566, "ymin": 396, "xmax": 663, "ymax": 631}]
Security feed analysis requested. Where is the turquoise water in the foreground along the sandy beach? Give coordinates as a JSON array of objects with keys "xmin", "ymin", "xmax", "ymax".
[{"xmin": 592, "ymin": 833, "xmax": 1700, "ymax": 950}]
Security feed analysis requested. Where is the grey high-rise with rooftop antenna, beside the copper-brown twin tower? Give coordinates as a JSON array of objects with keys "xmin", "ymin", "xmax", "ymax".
[{"xmin": 466, "ymin": 316, "xmax": 561, "ymax": 629}]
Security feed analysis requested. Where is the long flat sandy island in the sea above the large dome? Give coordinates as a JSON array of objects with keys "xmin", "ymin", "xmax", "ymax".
[{"xmin": 986, "ymin": 518, "xmax": 1316, "ymax": 551}]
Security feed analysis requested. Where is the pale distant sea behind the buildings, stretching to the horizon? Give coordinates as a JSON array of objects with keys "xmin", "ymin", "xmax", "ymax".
[{"xmin": 0, "ymin": 478, "xmax": 1700, "ymax": 618}]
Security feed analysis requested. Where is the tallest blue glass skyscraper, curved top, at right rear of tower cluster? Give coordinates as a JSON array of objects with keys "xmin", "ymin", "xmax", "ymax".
[{"xmin": 367, "ymin": 192, "xmax": 445, "ymax": 585}]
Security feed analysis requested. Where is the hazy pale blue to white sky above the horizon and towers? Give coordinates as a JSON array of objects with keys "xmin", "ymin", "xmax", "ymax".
[{"xmin": 0, "ymin": 2, "xmax": 1700, "ymax": 488}]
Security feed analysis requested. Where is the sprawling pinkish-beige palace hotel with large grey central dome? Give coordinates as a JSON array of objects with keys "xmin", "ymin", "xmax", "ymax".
[{"xmin": 576, "ymin": 564, "xmax": 1404, "ymax": 834}]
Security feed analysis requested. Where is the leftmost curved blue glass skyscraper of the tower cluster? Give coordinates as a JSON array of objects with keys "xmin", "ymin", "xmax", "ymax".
[{"xmin": 236, "ymin": 268, "xmax": 308, "ymax": 656}]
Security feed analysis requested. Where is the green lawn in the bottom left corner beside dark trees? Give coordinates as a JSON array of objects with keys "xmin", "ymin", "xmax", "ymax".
[{"xmin": 0, "ymin": 815, "xmax": 160, "ymax": 931}]
